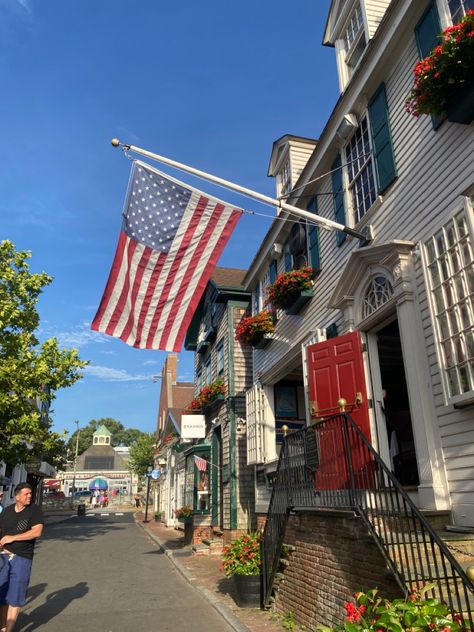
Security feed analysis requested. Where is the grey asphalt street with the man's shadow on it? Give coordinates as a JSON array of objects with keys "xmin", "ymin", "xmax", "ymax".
[{"xmin": 18, "ymin": 510, "xmax": 231, "ymax": 632}]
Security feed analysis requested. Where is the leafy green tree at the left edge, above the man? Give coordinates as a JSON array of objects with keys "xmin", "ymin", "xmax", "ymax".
[{"xmin": 0, "ymin": 241, "xmax": 87, "ymax": 465}]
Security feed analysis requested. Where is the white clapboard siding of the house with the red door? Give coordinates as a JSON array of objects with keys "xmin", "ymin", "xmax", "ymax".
[{"xmin": 254, "ymin": 14, "xmax": 474, "ymax": 525}]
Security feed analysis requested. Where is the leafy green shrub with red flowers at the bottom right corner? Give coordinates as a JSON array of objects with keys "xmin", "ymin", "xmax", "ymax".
[{"xmin": 316, "ymin": 584, "xmax": 467, "ymax": 632}]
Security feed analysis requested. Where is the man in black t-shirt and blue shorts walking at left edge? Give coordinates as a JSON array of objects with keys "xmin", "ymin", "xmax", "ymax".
[{"xmin": 0, "ymin": 483, "xmax": 44, "ymax": 632}]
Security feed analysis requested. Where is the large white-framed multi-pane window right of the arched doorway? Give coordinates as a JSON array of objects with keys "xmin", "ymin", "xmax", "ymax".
[{"xmin": 425, "ymin": 211, "xmax": 474, "ymax": 397}]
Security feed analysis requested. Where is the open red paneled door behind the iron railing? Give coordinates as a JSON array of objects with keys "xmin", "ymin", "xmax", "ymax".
[{"xmin": 308, "ymin": 331, "xmax": 372, "ymax": 490}]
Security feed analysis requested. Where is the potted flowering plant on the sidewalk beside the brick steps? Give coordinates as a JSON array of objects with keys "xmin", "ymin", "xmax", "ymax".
[{"xmin": 222, "ymin": 532, "xmax": 262, "ymax": 608}]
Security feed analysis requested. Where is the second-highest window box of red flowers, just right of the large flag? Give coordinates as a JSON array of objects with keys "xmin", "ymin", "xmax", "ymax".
[{"xmin": 267, "ymin": 267, "xmax": 315, "ymax": 314}]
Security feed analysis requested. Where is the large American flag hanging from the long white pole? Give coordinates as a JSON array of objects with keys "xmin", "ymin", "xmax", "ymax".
[{"xmin": 91, "ymin": 160, "xmax": 242, "ymax": 351}]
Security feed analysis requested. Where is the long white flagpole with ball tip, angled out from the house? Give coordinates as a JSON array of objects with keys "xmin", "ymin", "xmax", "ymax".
[{"xmin": 111, "ymin": 138, "xmax": 368, "ymax": 244}]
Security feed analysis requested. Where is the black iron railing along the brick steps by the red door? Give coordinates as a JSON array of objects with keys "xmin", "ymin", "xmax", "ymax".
[{"xmin": 262, "ymin": 413, "xmax": 474, "ymax": 630}]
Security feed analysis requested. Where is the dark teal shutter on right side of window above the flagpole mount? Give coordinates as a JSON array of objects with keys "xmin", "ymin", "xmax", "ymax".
[{"xmin": 368, "ymin": 83, "xmax": 397, "ymax": 194}]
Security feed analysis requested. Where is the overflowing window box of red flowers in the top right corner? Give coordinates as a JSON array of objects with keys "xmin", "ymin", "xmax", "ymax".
[{"xmin": 405, "ymin": 11, "xmax": 474, "ymax": 116}]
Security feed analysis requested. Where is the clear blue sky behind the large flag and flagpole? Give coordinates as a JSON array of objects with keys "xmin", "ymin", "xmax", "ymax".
[{"xmin": 0, "ymin": 0, "xmax": 337, "ymax": 440}]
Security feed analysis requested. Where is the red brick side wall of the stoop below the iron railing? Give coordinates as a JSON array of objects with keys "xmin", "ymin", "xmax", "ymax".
[{"xmin": 275, "ymin": 511, "xmax": 400, "ymax": 630}]
